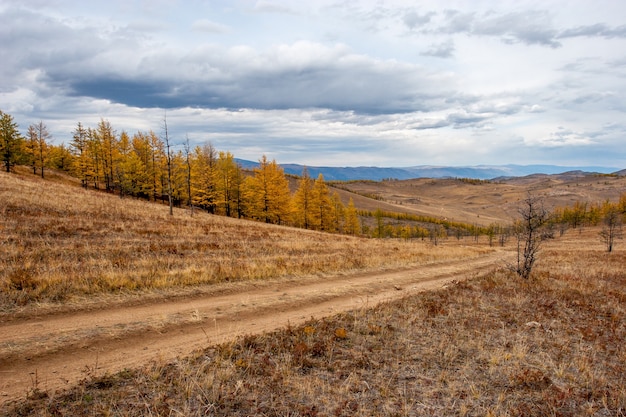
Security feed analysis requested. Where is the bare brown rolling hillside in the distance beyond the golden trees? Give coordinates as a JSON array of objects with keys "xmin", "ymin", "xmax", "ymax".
[{"xmin": 339, "ymin": 173, "xmax": 626, "ymax": 226}]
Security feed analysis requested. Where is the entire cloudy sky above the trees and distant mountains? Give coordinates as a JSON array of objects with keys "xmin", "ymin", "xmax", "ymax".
[{"xmin": 0, "ymin": 0, "xmax": 626, "ymax": 169}]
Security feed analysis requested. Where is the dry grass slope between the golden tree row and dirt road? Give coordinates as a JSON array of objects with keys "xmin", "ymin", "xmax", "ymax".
[{"xmin": 0, "ymin": 172, "xmax": 484, "ymax": 313}]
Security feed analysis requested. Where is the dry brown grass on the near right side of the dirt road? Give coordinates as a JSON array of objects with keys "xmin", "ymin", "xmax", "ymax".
[{"xmin": 3, "ymin": 236, "xmax": 626, "ymax": 416}]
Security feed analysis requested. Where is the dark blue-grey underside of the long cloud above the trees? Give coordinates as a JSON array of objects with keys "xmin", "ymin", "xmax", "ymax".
[{"xmin": 66, "ymin": 68, "xmax": 444, "ymax": 114}]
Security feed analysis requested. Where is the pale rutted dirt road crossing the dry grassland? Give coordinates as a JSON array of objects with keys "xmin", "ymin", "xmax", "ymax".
[{"xmin": 0, "ymin": 252, "xmax": 509, "ymax": 403}]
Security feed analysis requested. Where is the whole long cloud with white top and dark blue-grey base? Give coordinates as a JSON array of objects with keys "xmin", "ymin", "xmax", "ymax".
[{"xmin": 54, "ymin": 38, "xmax": 454, "ymax": 114}]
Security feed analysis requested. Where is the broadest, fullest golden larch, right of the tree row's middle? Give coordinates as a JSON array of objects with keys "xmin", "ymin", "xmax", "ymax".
[{"xmin": 244, "ymin": 155, "xmax": 291, "ymax": 224}]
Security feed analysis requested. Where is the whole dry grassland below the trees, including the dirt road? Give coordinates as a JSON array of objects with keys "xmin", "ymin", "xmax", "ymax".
[{"xmin": 0, "ymin": 173, "xmax": 626, "ymax": 416}]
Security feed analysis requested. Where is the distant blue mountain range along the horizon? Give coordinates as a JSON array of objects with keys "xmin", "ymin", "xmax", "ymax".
[{"xmin": 237, "ymin": 159, "xmax": 624, "ymax": 181}]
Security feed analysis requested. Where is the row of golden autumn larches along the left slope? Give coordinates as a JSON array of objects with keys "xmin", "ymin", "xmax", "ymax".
[{"xmin": 0, "ymin": 111, "xmax": 361, "ymax": 234}]
